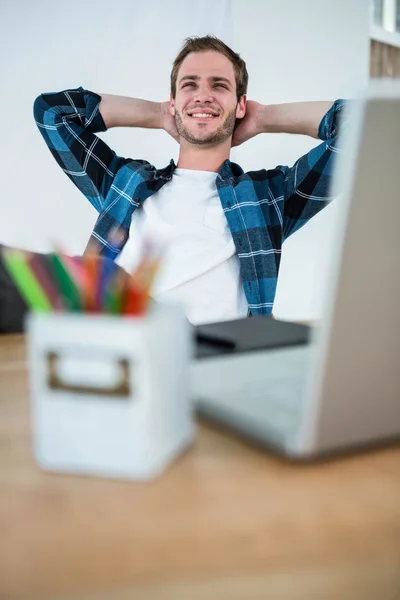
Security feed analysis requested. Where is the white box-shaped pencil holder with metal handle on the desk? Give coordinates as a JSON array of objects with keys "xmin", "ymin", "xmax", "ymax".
[{"xmin": 27, "ymin": 304, "xmax": 194, "ymax": 480}]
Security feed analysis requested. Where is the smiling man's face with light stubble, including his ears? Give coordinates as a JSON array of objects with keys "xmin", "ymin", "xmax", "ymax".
[{"xmin": 170, "ymin": 51, "xmax": 246, "ymax": 146}]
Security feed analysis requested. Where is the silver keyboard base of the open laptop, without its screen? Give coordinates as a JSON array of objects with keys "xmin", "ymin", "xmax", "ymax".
[{"xmin": 197, "ymin": 346, "xmax": 310, "ymax": 445}]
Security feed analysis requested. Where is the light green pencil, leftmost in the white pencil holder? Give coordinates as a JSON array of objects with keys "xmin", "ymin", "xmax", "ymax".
[{"xmin": 3, "ymin": 250, "xmax": 53, "ymax": 312}]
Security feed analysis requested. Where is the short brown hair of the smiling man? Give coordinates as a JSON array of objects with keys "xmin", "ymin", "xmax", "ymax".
[{"xmin": 171, "ymin": 35, "xmax": 249, "ymax": 102}]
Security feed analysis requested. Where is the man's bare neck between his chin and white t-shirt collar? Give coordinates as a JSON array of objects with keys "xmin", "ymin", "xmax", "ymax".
[{"xmin": 177, "ymin": 139, "xmax": 231, "ymax": 173}]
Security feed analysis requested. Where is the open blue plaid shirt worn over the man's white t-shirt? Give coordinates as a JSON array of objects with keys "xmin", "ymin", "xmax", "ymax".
[{"xmin": 34, "ymin": 87, "xmax": 345, "ymax": 315}]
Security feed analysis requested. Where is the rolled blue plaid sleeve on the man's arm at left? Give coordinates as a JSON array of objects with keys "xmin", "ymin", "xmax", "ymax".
[{"xmin": 33, "ymin": 87, "xmax": 124, "ymax": 212}]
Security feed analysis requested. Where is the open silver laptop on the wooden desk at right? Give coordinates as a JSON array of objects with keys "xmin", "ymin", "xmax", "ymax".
[{"xmin": 192, "ymin": 81, "xmax": 400, "ymax": 459}]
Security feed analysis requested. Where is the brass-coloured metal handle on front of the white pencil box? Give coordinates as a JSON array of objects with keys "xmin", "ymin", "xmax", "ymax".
[{"xmin": 47, "ymin": 352, "xmax": 131, "ymax": 398}]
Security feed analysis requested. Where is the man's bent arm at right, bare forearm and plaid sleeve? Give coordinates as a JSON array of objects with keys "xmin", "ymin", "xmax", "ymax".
[{"xmin": 232, "ymin": 100, "xmax": 346, "ymax": 239}]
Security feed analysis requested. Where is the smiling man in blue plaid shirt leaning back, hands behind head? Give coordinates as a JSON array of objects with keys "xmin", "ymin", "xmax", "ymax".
[{"xmin": 30, "ymin": 36, "xmax": 344, "ymax": 324}]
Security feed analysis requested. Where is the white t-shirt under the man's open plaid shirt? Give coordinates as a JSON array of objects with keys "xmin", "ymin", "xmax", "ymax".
[{"xmin": 116, "ymin": 168, "xmax": 248, "ymax": 325}]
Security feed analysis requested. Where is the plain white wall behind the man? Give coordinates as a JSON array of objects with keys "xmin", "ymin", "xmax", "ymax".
[{"xmin": 0, "ymin": 0, "xmax": 369, "ymax": 319}]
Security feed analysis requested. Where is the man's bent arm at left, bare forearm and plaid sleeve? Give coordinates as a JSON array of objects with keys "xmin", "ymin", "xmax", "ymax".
[{"xmin": 34, "ymin": 88, "xmax": 177, "ymax": 211}]
